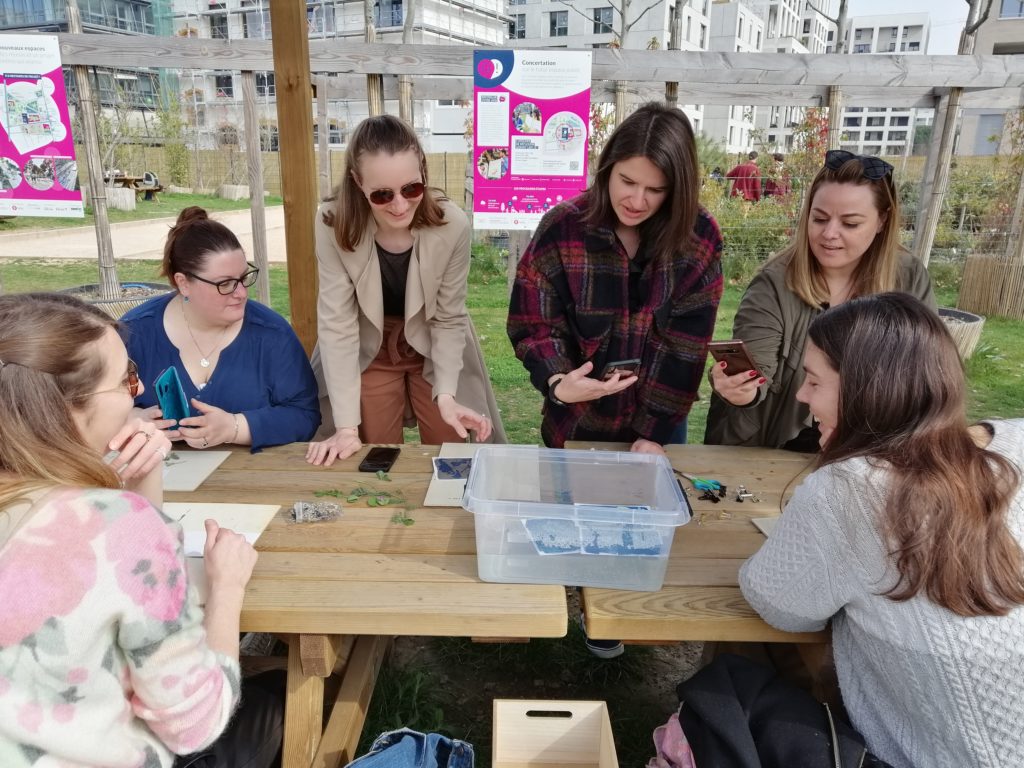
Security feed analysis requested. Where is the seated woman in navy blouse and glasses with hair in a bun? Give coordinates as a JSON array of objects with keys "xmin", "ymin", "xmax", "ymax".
[{"xmin": 122, "ymin": 207, "xmax": 319, "ymax": 451}]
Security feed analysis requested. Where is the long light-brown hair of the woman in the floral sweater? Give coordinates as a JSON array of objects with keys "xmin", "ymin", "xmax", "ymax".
[{"xmin": 0, "ymin": 293, "xmax": 120, "ymax": 510}]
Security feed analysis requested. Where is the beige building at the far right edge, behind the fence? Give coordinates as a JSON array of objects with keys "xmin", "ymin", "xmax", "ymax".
[{"xmin": 956, "ymin": 0, "xmax": 1024, "ymax": 155}]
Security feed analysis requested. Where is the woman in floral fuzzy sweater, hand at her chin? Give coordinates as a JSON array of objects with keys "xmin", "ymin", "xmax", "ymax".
[{"xmin": 0, "ymin": 294, "xmax": 280, "ymax": 768}]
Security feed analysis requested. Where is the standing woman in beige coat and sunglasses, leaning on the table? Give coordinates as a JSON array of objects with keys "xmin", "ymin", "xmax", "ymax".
[{"xmin": 306, "ymin": 115, "xmax": 504, "ymax": 466}]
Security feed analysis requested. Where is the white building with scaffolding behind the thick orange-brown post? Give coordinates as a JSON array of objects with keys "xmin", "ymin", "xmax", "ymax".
[{"xmin": 174, "ymin": 0, "xmax": 510, "ymax": 153}]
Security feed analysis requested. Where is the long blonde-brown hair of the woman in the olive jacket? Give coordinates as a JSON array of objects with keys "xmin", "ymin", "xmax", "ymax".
[{"xmin": 775, "ymin": 158, "xmax": 906, "ymax": 307}]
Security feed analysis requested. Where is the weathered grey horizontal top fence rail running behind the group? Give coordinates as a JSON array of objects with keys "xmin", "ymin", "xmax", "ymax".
[{"xmin": 51, "ymin": 34, "xmax": 1024, "ymax": 89}]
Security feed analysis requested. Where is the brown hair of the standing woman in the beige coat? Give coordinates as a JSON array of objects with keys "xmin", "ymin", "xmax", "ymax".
[{"xmin": 323, "ymin": 115, "xmax": 445, "ymax": 251}]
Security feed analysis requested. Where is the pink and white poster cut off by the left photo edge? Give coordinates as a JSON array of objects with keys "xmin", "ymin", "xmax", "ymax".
[{"xmin": 0, "ymin": 35, "xmax": 84, "ymax": 218}]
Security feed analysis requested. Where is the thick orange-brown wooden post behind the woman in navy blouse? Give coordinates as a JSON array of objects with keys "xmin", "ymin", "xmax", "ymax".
[{"xmin": 270, "ymin": 0, "xmax": 318, "ymax": 353}]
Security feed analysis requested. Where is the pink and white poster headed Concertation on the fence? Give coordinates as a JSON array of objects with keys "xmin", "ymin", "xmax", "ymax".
[{"xmin": 473, "ymin": 50, "xmax": 591, "ymax": 229}]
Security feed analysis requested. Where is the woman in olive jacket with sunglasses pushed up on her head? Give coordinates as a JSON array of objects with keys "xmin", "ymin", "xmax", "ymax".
[{"xmin": 705, "ymin": 150, "xmax": 936, "ymax": 453}]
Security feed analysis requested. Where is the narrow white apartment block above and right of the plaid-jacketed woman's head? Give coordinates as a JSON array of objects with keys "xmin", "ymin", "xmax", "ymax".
[{"xmin": 703, "ymin": 0, "xmax": 765, "ymax": 155}]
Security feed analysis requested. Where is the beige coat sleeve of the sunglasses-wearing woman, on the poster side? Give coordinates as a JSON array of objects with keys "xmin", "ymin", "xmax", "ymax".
[{"xmin": 420, "ymin": 205, "xmax": 470, "ymax": 398}]
